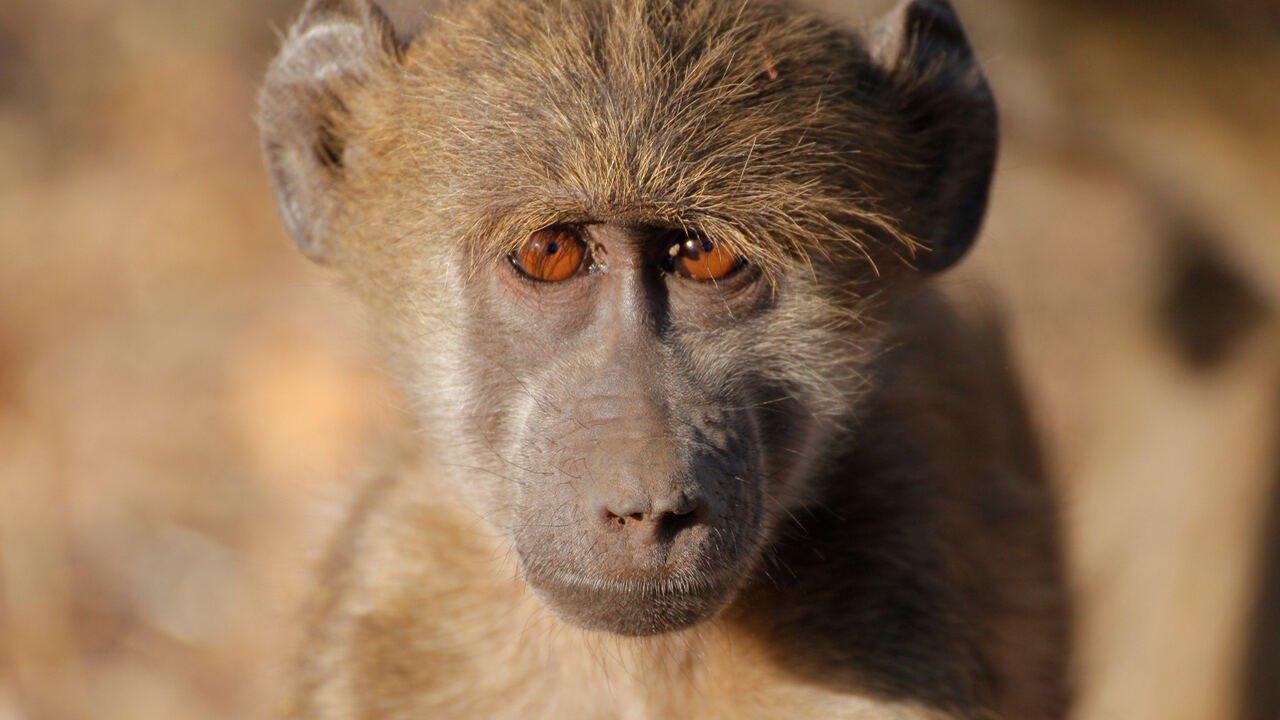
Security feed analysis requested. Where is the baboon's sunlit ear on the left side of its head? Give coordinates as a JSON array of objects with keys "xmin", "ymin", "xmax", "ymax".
[{"xmin": 259, "ymin": 0, "xmax": 402, "ymax": 261}]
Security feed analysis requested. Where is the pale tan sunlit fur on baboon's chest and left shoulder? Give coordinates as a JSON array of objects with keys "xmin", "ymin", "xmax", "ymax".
[{"xmin": 291, "ymin": 453, "xmax": 962, "ymax": 720}]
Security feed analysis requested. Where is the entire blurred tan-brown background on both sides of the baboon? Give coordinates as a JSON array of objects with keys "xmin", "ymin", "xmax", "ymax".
[{"xmin": 0, "ymin": 0, "xmax": 1280, "ymax": 720}]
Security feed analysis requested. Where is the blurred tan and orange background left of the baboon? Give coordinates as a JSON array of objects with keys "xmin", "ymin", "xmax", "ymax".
[{"xmin": 0, "ymin": 1, "xmax": 392, "ymax": 720}]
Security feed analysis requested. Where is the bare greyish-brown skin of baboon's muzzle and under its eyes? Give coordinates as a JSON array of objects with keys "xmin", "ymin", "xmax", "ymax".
[{"xmin": 467, "ymin": 223, "xmax": 773, "ymax": 634}]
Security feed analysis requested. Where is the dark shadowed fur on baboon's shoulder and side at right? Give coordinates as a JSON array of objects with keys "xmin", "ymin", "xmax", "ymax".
[{"xmin": 731, "ymin": 304, "xmax": 1069, "ymax": 719}]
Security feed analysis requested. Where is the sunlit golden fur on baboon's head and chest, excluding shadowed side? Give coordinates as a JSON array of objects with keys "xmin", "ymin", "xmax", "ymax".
[{"xmin": 254, "ymin": 0, "xmax": 1053, "ymax": 720}]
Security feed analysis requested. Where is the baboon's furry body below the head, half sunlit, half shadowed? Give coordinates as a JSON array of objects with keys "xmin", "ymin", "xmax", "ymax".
[{"xmin": 282, "ymin": 289, "xmax": 1068, "ymax": 720}]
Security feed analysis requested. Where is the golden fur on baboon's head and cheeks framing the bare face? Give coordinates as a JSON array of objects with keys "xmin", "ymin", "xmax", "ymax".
[{"xmin": 264, "ymin": 0, "xmax": 916, "ymax": 486}]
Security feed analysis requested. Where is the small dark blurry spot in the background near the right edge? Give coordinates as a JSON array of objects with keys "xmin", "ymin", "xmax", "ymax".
[{"xmin": 1158, "ymin": 227, "xmax": 1267, "ymax": 372}]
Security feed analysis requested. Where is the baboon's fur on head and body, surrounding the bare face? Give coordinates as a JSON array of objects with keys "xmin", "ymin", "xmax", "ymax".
[{"xmin": 254, "ymin": 0, "xmax": 1061, "ymax": 720}]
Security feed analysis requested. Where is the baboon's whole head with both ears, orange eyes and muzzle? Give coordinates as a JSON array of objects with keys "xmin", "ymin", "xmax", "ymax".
[{"xmin": 260, "ymin": 0, "xmax": 996, "ymax": 635}]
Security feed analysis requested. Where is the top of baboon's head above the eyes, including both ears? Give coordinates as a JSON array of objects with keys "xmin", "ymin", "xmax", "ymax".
[{"xmin": 260, "ymin": 0, "xmax": 995, "ymax": 278}]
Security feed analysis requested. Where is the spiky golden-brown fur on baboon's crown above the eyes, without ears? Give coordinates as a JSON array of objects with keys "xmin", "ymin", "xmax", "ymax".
[{"xmin": 311, "ymin": 0, "xmax": 918, "ymax": 280}]
